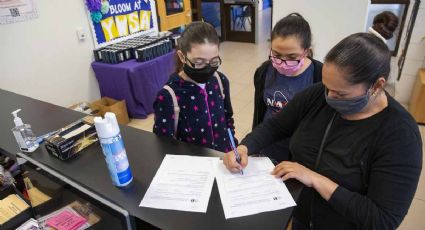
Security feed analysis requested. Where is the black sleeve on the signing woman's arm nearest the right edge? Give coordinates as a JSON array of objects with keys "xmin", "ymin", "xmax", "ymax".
[{"xmin": 329, "ymin": 117, "xmax": 422, "ymax": 229}]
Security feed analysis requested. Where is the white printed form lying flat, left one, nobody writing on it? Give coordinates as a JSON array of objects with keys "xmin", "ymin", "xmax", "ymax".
[{"xmin": 139, "ymin": 154, "xmax": 219, "ymax": 213}]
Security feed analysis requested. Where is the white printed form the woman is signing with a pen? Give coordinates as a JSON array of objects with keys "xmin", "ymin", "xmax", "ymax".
[{"xmin": 216, "ymin": 157, "xmax": 296, "ymax": 219}]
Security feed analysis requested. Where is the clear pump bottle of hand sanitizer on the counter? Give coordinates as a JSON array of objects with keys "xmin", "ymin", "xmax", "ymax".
[{"xmin": 12, "ymin": 109, "xmax": 38, "ymax": 153}]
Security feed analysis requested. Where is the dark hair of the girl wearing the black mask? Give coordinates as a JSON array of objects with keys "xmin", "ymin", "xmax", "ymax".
[{"xmin": 176, "ymin": 21, "xmax": 220, "ymax": 73}]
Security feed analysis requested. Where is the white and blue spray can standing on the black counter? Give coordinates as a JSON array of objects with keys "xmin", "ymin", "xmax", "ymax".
[{"xmin": 94, "ymin": 112, "xmax": 133, "ymax": 187}]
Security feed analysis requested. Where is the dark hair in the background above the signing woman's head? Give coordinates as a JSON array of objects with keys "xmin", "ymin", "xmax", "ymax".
[{"xmin": 372, "ymin": 11, "xmax": 398, "ymax": 40}]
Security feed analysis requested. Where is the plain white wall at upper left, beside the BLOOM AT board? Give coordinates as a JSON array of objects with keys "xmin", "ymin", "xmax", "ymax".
[{"xmin": 0, "ymin": 0, "xmax": 100, "ymax": 106}]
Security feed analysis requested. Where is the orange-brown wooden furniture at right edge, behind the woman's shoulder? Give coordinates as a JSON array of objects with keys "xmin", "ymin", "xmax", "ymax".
[{"xmin": 409, "ymin": 69, "xmax": 425, "ymax": 124}]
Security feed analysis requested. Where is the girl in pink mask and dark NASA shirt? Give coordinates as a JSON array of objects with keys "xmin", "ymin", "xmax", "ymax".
[{"xmin": 252, "ymin": 13, "xmax": 322, "ymax": 163}]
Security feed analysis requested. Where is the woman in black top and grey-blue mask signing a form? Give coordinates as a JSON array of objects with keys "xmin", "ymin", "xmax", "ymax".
[{"xmin": 223, "ymin": 33, "xmax": 423, "ymax": 230}]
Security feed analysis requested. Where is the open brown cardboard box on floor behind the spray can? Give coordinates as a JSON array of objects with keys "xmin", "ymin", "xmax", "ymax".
[{"xmin": 90, "ymin": 97, "xmax": 130, "ymax": 125}]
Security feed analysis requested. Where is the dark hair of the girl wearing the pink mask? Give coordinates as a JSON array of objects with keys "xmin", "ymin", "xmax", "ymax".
[{"xmin": 271, "ymin": 13, "xmax": 311, "ymax": 49}]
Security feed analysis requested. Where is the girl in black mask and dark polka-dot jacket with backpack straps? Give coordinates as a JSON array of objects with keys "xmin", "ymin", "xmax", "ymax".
[{"xmin": 153, "ymin": 22, "xmax": 237, "ymax": 152}]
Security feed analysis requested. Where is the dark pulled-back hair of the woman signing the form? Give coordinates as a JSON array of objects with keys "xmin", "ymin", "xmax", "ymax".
[{"xmin": 325, "ymin": 33, "xmax": 391, "ymax": 85}]
